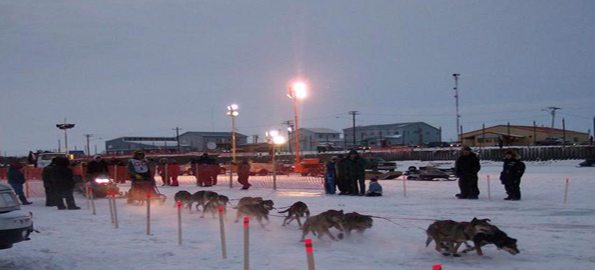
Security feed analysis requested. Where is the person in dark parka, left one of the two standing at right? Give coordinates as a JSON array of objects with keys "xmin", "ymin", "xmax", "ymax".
[{"xmin": 455, "ymin": 146, "xmax": 481, "ymax": 199}]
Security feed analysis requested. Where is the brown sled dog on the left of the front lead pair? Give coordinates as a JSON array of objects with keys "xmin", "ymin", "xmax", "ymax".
[{"xmin": 426, "ymin": 218, "xmax": 493, "ymax": 257}]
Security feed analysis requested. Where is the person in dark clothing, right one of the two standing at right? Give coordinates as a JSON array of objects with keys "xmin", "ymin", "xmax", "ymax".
[{"xmin": 500, "ymin": 150, "xmax": 525, "ymax": 201}]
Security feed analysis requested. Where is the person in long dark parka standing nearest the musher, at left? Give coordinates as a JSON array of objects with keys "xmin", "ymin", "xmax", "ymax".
[{"xmin": 50, "ymin": 157, "xmax": 81, "ymax": 210}]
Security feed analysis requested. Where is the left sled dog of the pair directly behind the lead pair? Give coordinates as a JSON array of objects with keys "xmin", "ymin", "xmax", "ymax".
[{"xmin": 301, "ymin": 210, "xmax": 344, "ymax": 241}]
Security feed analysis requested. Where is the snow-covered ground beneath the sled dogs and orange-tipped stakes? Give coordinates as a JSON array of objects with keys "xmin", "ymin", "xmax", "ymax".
[{"xmin": 0, "ymin": 161, "xmax": 595, "ymax": 270}]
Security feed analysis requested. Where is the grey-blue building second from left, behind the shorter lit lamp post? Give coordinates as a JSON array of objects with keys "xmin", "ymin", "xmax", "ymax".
[{"xmin": 180, "ymin": 131, "xmax": 248, "ymax": 152}]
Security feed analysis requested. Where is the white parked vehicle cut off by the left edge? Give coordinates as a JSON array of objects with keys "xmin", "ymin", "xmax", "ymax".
[{"xmin": 0, "ymin": 184, "xmax": 33, "ymax": 249}]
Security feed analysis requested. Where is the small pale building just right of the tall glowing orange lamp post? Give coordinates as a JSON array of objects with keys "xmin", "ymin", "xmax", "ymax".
[{"xmin": 288, "ymin": 128, "xmax": 343, "ymax": 151}]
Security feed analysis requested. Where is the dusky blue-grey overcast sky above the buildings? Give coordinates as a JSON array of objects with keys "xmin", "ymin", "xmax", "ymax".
[{"xmin": 0, "ymin": 0, "xmax": 595, "ymax": 155}]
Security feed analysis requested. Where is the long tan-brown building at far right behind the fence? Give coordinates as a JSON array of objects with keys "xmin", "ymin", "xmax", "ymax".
[{"xmin": 461, "ymin": 125, "xmax": 589, "ymax": 146}]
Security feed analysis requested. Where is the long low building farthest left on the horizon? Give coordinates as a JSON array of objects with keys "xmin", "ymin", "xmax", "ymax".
[{"xmin": 105, "ymin": 137, "xmax": 178, "ymax": 154}]
